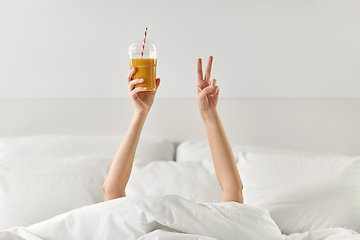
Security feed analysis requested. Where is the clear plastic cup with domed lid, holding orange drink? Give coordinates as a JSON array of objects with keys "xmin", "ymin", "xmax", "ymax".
[{"xmin": 128, "ymin": 40, "xmax": 157, "ymax": 91}]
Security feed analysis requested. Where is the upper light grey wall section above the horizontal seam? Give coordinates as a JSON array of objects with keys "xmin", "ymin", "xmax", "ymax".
[{"xmin": 0, "ymin": 0, "xmax": 360, "ymax": 99}]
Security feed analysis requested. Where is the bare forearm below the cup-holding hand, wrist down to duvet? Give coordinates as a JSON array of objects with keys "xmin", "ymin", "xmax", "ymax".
[{"xmin": 103, "ymin": 112, "xmax": 147, "ymax": 201}]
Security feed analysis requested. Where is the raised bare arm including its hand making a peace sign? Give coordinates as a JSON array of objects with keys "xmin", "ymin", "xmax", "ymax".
[{"xmin": 197, "ymin": 56, "xmax": 243, "ymax": 203}]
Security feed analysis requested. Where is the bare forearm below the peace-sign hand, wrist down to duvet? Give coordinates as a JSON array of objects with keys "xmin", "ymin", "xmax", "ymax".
[{"xmin": 200, "ymin": 109, "xmax": 242, "ymax": 200}]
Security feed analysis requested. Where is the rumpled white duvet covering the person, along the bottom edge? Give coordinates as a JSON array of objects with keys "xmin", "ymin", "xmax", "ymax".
[{"xmin": 0, "ymin": 195, "xmax": 360, "ymax": 240}]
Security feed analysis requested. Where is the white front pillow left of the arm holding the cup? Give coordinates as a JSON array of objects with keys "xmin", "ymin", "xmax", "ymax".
[{"xmin": 0, "ymin": 157, "xmax": 112, "ymax": 231}]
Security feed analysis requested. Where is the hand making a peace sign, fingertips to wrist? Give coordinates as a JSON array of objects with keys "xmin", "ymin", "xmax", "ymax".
[{"xmin": 197, "ymin": 56, "xmax": 219, "ymax": 111}]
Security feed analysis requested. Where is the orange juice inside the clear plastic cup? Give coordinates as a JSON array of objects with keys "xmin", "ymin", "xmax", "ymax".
[{"xmin": 130, "ymin": 58, "xmax": 157, "ymax": 91}]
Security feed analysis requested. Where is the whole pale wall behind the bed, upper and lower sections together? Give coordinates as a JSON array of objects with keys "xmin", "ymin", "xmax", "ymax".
[{"xmin": 0, "ymin": 0, "xmax": 360, "ymax": 154}]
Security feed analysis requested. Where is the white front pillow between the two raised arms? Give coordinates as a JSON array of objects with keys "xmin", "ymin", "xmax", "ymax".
[{"xmin": 125, "ymin": 160, "xmax": 222, "ymax": 203}]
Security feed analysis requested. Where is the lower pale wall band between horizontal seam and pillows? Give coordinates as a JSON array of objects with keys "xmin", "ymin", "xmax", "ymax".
[{"xmin": 0, "ymin": 99, "xmax": 360, "ymax": 155}]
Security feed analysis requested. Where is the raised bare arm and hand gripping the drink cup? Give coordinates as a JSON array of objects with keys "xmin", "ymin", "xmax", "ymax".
[{"xmin": 103, "ymin": 68, "xmax": 160, "ymax": 201}]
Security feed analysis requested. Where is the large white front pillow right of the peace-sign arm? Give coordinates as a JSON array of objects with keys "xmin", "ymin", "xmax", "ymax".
[{"xmin": 237, "ymin": 153, "xmax": 360, "ymax": 234}]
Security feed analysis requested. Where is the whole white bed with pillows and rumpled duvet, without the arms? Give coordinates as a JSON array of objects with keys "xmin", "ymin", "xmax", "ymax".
[{"xmin": 0, "ymin": 136, "xmax": 360, "ymax": 240}]
